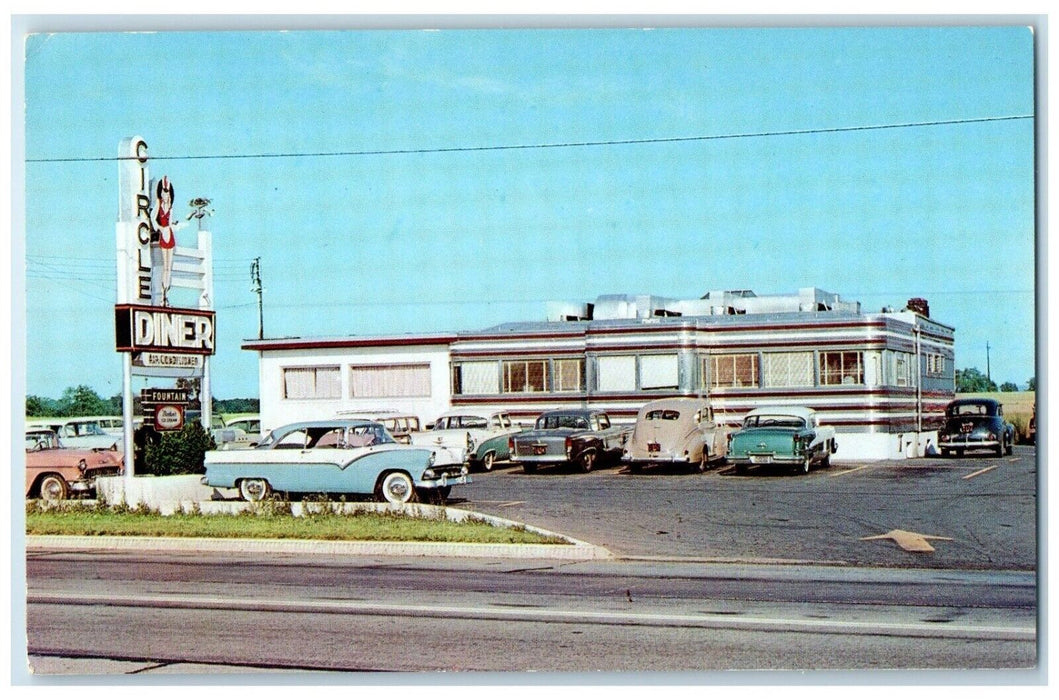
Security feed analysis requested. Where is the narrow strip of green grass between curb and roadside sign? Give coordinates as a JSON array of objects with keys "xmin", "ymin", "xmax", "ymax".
[{"xmin": 25, "ymin": 506, "xmax": 569, "ymax": 544}]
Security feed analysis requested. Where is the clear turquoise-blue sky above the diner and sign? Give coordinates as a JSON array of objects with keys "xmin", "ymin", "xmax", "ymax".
[{"xmin": 13, "ymin": 21, "xmax": 1035, "ymax": 398}]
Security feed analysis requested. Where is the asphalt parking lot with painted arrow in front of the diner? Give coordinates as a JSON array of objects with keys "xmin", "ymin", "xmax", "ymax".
[{"xmin": 450, "ymin": 446, "xmax": 1038, "ymax": 571}]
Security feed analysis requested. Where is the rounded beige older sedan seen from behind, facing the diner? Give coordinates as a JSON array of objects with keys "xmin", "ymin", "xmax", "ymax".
[{"xmin": 622, "ymin": 398, "xmax": 729, "ymax": 472}]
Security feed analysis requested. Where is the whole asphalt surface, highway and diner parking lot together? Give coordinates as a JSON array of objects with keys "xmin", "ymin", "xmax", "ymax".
[{"xmin": 20, "ymin": 446, "xmax": 1038, "ymax": 683}]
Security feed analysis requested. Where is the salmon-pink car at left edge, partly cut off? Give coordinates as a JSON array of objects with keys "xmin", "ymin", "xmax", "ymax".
[{"xmin": 25, "ymin": 428, "xmax": 125, "ymax": 502}]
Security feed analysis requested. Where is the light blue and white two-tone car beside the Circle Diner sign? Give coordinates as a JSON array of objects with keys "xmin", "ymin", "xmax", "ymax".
[{"xmin": 202, "ymin": 418, "xmax": 470, "ymax": 503}]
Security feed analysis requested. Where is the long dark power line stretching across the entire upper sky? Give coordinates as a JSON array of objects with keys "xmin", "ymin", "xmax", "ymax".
[{"xmin": 25, "ymin": 114, "xmax": 1035, "ymax": 163}]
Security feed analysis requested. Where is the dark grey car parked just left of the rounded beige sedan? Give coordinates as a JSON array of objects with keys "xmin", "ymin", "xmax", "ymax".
[{"xmin": 508, "ymin": 409, "xmax": 632, "ymax": 473}]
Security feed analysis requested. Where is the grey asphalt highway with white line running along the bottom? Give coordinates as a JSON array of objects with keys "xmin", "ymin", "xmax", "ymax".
[{"xmin": 26, "ymin": 551, "xmax": 1036, "ymax": 682}]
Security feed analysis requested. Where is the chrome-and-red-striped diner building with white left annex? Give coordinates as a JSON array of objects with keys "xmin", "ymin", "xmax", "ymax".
[{"xmin": 243, "ymin": 288, "xmax": 955, "ymax": 461}]
